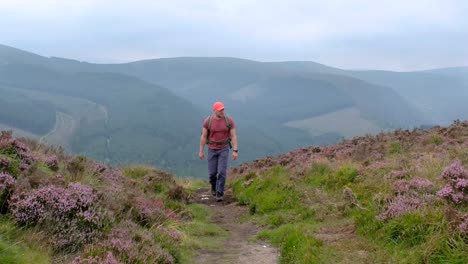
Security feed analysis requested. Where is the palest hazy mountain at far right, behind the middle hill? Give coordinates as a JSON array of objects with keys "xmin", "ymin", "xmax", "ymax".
[{"xmin": 277, "ymin": 62, "xmax": 468, "ymax": 125}]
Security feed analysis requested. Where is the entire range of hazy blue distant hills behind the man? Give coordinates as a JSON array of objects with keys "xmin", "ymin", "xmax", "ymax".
[{"xmin": 0, "ymin": 45, "xmax": 468, "ymax": 176}]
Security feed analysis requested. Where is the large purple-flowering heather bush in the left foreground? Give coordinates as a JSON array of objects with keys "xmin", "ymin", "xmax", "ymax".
[{"xmin": 10, "ymin": 183, "xmax": 103, "ymax": 251}]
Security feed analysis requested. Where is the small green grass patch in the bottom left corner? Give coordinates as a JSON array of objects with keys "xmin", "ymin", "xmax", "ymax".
[{"xmin": 0, "ymin": 216, "xmax": 50, "ymax": 264}]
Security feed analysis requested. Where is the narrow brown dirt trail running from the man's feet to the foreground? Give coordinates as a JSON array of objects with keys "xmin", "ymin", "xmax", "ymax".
[{"xmin": 194, "ymin": 189, "xmax": 279, "ymax": 264}]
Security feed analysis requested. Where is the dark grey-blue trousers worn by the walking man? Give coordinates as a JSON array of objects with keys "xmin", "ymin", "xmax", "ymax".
[{"xmin": 208, "ymin": 146, "xmax": 229, "ymax": 195}]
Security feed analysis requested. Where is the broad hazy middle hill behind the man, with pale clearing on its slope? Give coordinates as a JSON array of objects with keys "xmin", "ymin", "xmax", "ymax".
[{"xmin": 53, "ymin": 54, "xmax": 426, "ymax": 150}]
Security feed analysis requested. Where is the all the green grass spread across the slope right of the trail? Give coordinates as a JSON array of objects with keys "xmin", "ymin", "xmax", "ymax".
[{"xmin": 232, "ymin": 154, "xmax": 468, "ymax": 263}]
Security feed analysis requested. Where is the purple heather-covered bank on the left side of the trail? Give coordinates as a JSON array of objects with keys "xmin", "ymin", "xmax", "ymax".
[{"xmin": 0, "ymin": 131, "xmax": 199, "ymax": 263}]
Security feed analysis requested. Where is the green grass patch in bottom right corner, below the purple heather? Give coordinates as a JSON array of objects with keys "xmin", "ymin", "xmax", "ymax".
[{"xmin": 348, "ymin": 191, "xmax": 468, "ymax": 263}]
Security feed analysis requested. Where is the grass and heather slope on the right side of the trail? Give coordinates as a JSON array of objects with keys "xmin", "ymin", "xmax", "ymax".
[{"xmin": 230, "ymin": 121, "xmax": 468, "ymax": 263}]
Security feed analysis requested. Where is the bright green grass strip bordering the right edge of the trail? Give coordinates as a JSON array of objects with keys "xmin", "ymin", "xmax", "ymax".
[{"xmin": 232, "ymin": 165, "xmax": 330, "ymax": 263}]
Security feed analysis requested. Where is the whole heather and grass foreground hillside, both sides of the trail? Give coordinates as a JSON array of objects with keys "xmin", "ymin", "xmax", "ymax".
[{"xmin": 0, "ymin": 121, "xmax": 468, "ymax": 264}]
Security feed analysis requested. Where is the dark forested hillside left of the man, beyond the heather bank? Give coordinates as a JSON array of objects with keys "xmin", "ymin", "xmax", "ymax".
[{"xmin": 0, "ymin": 53, "xmax": 205, "ymax": 175}]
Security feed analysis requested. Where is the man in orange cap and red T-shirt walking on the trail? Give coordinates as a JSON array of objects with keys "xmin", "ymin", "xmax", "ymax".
[{"xmin": 198, "ymin": 102, "xmax": 238, "ymax": 202}]
